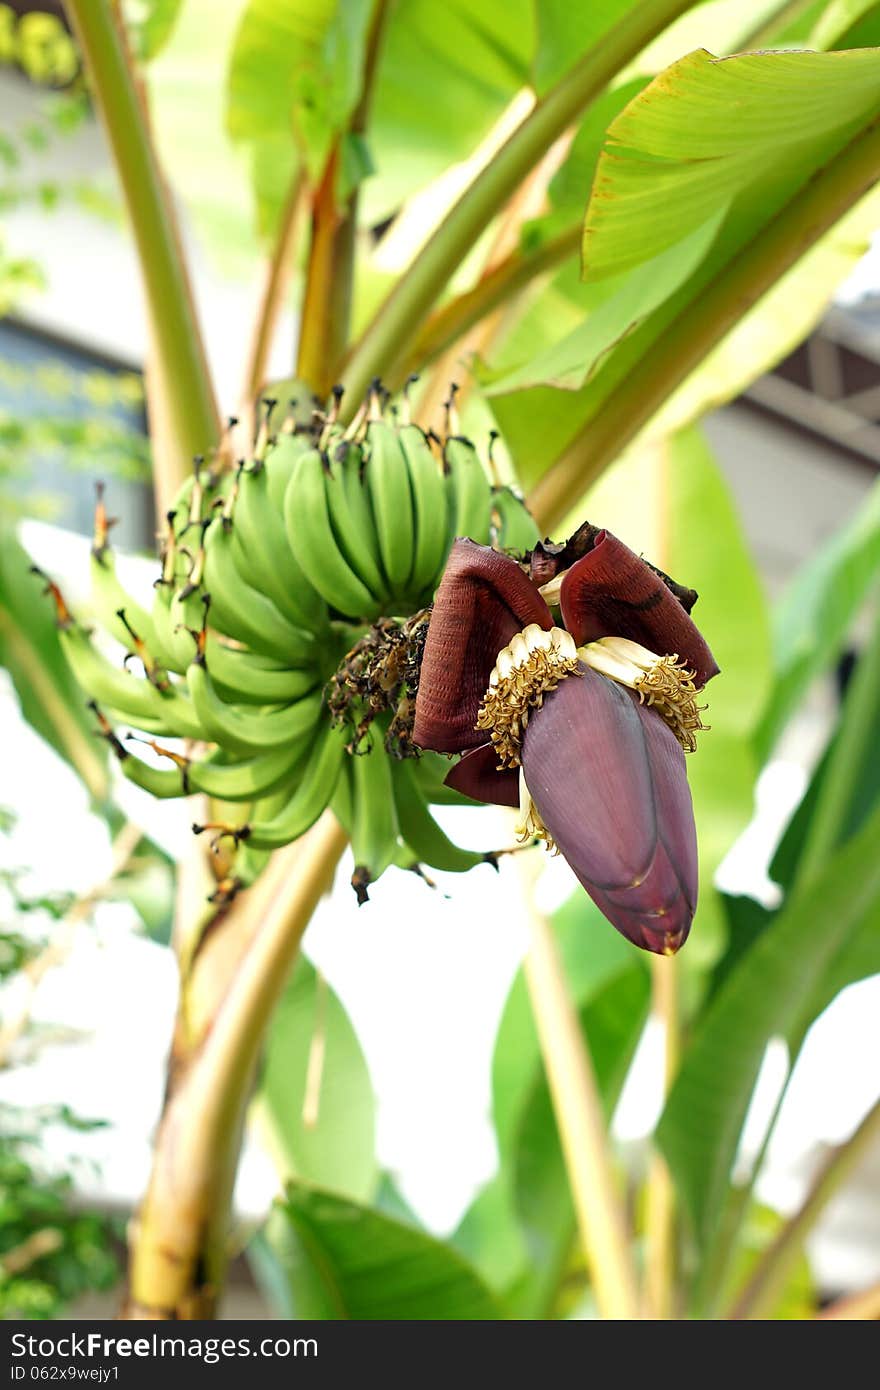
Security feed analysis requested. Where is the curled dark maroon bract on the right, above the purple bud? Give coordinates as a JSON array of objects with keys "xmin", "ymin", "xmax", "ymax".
[{"xmin": 559, "ymin": 531, "xmax": 719, "ymax": 689}]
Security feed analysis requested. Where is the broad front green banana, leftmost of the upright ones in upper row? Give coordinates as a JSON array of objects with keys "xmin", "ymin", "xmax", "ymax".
[{"xmin": 284, "ymin": 449, "xmax": 381, "ymax": 621}]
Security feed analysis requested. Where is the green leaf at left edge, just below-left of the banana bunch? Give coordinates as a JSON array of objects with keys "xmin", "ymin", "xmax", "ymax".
[{"xmin": 0, "ymin": 527, "xmax": 110, "ymax": 802}]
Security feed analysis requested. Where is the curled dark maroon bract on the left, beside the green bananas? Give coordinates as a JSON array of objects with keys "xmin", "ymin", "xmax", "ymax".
[{"xmin": 413, "ymin": 541, "xmax": 553, "ymax": 753}]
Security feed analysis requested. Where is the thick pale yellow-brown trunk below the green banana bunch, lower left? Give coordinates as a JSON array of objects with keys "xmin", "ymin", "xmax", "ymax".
[{"xmin": 122, "ymin": 812, "xmax": 348, "ymax": 1321}]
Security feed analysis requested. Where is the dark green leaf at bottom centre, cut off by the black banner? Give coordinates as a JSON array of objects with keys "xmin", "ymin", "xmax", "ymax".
[{"xmin": 266, "ymin": 1183, "xmax": 500, "ymax": 1322}]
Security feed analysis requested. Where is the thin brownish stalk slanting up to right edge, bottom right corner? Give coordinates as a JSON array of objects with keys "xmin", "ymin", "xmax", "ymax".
[{"xmin": 730, "ymin": 1101, "xmax": 880, "ymax": 1319}]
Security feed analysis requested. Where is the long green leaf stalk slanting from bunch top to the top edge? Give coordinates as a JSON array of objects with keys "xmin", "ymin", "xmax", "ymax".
[{"xmin": 336, "ymin": 0, "xmax": 695, "ymax": 416}]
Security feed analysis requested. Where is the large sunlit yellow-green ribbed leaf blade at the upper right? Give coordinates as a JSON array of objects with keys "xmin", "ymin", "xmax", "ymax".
[{"xmin": 489, "ymin": 50, "xmax": 880, "ymax": 482}]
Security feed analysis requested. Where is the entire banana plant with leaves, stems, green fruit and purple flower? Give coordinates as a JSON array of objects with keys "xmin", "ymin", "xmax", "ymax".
[{"xmin": 1, "ymin": 0, "xmax": 880, "ymax": 1319}]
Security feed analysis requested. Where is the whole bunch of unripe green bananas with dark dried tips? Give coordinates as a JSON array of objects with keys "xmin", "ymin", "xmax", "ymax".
[{"xmin": 49, "ymin": 389, "xmax": 538, "ymax": 901}]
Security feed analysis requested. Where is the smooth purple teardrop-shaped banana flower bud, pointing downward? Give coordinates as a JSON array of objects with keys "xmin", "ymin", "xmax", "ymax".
[{"xmin": 523, "ymin": 667, "xmax": 696, "ymax": 954}]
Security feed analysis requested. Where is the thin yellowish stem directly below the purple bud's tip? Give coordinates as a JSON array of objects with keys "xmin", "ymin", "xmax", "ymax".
[{"xmin": 645, "ymin": 956, "xmax": 681, "ymax": 1319}]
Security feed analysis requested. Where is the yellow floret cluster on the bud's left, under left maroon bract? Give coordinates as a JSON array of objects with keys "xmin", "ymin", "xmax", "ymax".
[{"xmin": 475, "ymin": 623, "xmax": 578, "ymax": 767}]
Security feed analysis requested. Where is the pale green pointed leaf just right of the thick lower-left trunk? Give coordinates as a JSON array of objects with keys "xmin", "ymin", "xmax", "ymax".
[{"xmin": 256, "ymin": 956, "xmax": 377, "ymax": 1200}]
